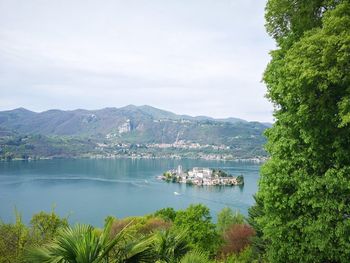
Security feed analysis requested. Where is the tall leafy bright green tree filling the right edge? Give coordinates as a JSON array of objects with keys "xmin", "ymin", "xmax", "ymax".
[{"xmin": 252, "ymin": 0, "xmax": 350, "ymax": 262}]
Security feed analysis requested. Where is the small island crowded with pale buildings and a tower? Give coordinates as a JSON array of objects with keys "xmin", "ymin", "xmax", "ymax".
[{"xmin": 158, "ymin": 165, "xmax": 244, "ymax": 186}]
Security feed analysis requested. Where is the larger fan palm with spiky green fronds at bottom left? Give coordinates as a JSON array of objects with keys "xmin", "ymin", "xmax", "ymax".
[{"xmin": 27, "ymin": 220, "xmax": 145, "ymax": 263}]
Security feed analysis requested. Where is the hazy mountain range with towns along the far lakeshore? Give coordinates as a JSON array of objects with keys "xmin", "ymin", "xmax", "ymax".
[{"xmin": 0, "ymin": 105, "xmax": 271, "ymax": 162}]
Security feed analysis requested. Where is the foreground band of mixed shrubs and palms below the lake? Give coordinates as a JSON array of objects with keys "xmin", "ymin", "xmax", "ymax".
[{"xmin": 0, "ymin": 205, "xmax": 254, "ymax": 263}]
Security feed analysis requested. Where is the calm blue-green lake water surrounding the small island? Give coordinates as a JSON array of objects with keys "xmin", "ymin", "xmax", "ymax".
[{"xmin": 0, "ymin": 159, "xmax": 260, "ymax": 226}]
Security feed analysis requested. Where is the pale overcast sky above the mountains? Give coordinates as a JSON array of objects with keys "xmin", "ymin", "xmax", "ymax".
[{"xmin": 0, "ymin": 0, "xmax": 275, "ymax": 122}]
